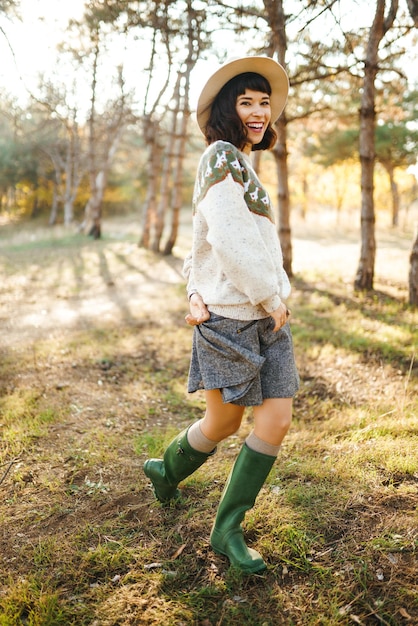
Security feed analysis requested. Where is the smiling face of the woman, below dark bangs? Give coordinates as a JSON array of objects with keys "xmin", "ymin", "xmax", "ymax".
[{"xmin": 236, "ymin": 89, "xmax": 271, "ymax": 154}]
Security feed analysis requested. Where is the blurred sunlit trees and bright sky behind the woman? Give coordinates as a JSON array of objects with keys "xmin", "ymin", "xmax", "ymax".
[{"xmin": 0, "ymin": 0, "xmax": 418, "ymax": 301}]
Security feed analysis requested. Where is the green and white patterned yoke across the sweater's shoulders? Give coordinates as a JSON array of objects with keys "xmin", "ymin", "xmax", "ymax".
[{"xmin": 193, "ymin": 141, "xmax": 274, "ymax": 222}]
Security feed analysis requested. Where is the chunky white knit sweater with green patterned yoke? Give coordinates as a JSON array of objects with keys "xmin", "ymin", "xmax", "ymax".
[{"xmin": 183, "ymin": 141, "xmax": 290, "ymax": 320}]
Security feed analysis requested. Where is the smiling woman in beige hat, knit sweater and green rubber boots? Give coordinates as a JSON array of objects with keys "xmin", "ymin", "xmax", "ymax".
[{"xmin": 144, "ymin": 57, "xmax": 299, "ymax": 573}]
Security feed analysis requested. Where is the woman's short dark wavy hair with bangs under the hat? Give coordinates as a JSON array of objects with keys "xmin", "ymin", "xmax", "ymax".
[{"xmin": 205, "ymin": 72, "xmax": 277, "ymax": 150}]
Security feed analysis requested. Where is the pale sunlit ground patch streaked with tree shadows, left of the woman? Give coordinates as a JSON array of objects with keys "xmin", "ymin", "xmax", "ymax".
[{"xmin": 0, "ymin": 242, "xmax": 183, "ymax": 347}]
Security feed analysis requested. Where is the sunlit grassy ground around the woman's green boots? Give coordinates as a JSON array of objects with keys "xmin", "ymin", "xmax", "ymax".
[{"xmin": 0, "ymin": 221, "xmax": 418, "ymax": 626}]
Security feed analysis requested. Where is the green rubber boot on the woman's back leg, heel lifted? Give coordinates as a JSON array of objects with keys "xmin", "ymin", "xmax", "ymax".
[{"xmin": 144, "ymin": 428, "xmax": 216, "ymax": 503}]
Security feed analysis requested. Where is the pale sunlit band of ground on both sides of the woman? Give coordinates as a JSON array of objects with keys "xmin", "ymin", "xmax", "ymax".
[{"xmin": 0, "ymin": 210, "xmax": 412, "ymax": 347}]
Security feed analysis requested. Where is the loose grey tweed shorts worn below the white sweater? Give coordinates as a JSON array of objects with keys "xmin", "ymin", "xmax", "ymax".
[{"xmin": 188, "ymin": 313, "xmax": 299, "ymax": 406}]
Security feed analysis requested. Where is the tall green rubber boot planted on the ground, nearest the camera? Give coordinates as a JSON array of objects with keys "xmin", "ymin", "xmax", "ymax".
[{"xmin": 210, "ymin": 444, "xmax": 276, "ymax": 574}]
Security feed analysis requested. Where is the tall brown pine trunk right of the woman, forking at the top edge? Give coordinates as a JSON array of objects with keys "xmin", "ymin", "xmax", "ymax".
[{"xmin": 354, "ymin": 0, "xmax": 398, "ymax": 291}]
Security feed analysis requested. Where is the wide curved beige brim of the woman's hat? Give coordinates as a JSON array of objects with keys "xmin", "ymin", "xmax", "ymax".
[{"xmin": 196, "ymin": 57, "xmax": 289, "ymax": 134}]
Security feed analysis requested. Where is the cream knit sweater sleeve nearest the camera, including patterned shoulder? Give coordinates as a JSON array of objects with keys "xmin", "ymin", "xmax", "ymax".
[{"xmin": 198, "ymin": 146, "xmax": 281, "ymax": 313}]
